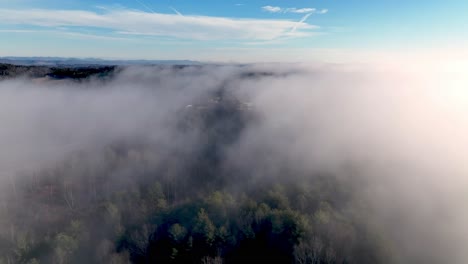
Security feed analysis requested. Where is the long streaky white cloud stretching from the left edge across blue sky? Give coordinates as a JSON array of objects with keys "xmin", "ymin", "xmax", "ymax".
[{"xmin": 0, "ymin": 9, "xmax": 318, "ymax": 41}]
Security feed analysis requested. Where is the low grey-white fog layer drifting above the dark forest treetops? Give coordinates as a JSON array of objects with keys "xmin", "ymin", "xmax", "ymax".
[{"xmin": 0, "ymin": 65, "xmax": 468, "ymax": 264}]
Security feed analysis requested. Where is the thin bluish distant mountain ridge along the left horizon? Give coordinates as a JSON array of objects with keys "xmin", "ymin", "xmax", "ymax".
[{"xmin": 0, "ymin": 57, "xmax": 202, "ymax": 66}]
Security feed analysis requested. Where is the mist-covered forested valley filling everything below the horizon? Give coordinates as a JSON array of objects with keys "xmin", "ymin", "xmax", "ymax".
[{"xmin": 0, "ymin": 64, "xmax": 468, "ymax": 264}]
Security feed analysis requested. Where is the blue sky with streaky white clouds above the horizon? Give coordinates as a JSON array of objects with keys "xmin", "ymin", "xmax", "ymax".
[{"xmin": 0, "ymin": 0, "xmax": 468, "ymax": 62}]
